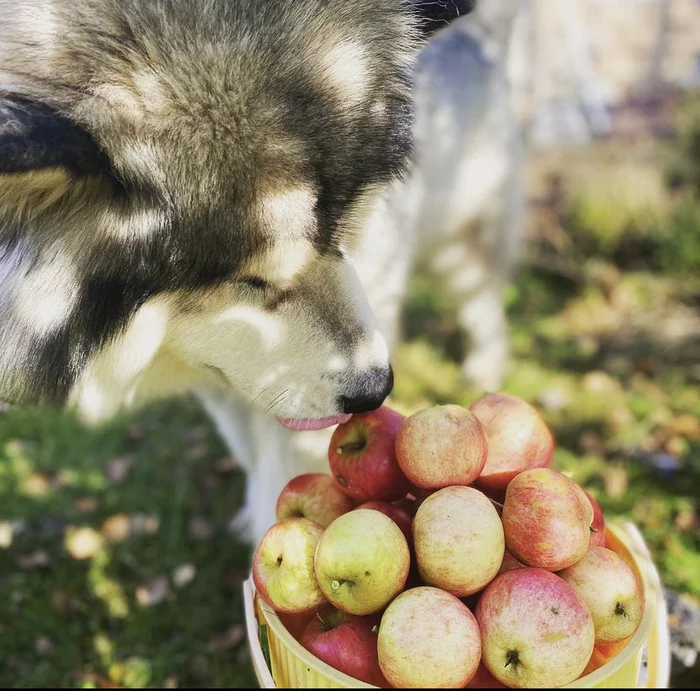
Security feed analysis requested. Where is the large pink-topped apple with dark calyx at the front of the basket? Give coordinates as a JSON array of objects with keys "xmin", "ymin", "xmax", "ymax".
[{"xmin": 474, "ymin": 567, "xmax": 595, "ymax": 688}]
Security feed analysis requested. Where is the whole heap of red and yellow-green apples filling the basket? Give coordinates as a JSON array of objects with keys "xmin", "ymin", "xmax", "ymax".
[{"xmin": 253, "ymin": 393, "xmax": 644, "ymax": 688}]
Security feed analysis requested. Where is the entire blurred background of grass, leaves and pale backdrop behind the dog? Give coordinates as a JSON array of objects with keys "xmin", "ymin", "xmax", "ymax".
[{"xmin": 0, "ymin": 0, "xmax": 700, "ymax": 688}]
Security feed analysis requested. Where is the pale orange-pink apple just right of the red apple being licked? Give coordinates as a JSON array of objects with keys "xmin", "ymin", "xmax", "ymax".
[{"xmin": 396, "ymin": 405, "xmax": 488, "ymax": 489}]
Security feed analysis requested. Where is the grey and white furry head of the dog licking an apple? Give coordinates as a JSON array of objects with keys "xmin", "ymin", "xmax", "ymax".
[{"xmin": 0, "ymin": 0, "xmax": 473, "ymax": 426}]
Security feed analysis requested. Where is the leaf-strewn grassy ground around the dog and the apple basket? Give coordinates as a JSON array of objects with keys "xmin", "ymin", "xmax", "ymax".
[{"xmin": 0, "ymin": 100, "xmax": 700, "ymax": 688}]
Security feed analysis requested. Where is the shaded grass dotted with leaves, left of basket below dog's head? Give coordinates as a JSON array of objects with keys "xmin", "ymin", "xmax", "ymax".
[{"xmin": 0, "ymin": 401, "xmax": 254, "ymax": 688}]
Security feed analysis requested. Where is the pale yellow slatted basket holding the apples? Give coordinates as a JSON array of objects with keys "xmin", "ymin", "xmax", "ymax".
[{"xmin": 244, "ymin": 523, "xmax": 670, "ymax": 689}]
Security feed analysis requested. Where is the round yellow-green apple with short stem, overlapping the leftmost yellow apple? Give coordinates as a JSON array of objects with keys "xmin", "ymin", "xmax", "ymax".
[{"xmin": 315, "ymin": 509, "xmax": 411, "ymax": 616}]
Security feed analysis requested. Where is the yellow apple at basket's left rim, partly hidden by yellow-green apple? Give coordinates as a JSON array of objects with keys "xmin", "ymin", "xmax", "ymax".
[{"xmin": 252, "ymin": 518, "xmax": 324, "ymax": 614}]
